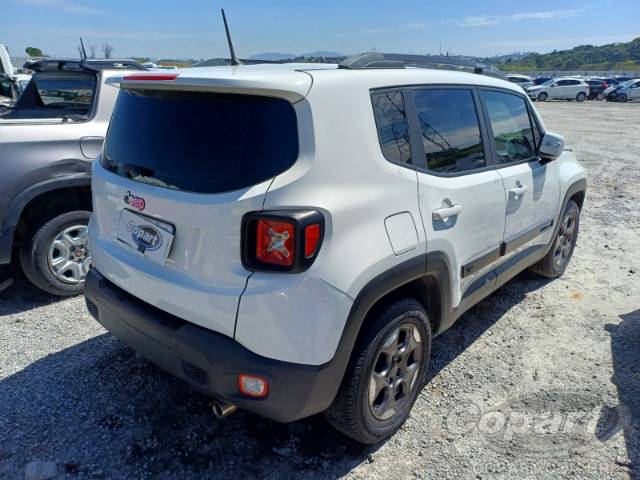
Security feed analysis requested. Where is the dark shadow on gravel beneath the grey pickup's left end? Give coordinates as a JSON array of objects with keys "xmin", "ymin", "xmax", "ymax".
[{"xmin": 0, "ymin": 266, "xmax": 63, "ymax": 316}]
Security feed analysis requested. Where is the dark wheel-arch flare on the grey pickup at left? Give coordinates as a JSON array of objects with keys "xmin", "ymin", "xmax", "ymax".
[{"xmin": 0, "ymin": 173, "xmax": 91, "ymax": 265}]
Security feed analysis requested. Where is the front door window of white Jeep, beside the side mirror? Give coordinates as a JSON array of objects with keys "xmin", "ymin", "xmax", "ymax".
[{"xmin": 480, "ymin": 90, "xmax": 536, "ymax": 164}]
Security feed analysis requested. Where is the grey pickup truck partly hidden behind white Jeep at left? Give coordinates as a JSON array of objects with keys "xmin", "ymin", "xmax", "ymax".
[{"xmin": 0, "ymin": 59, "xmax": 142, "ymax": 295}]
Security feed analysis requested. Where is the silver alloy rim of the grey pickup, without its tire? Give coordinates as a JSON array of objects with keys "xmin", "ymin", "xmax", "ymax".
[{"xmin": 47, "ymin": 225, "xmax": 91, "ymax": 284}]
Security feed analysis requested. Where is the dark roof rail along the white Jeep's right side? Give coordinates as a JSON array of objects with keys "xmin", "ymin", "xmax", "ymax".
[{"xmin": 338, "ymin": 52, "xmax": 506, "ymax": 79}]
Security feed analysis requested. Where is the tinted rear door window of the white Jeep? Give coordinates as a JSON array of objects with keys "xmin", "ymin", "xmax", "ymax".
[{"xmin": 414, "ymin": 88, "xmax": 485, "ymax": 173}]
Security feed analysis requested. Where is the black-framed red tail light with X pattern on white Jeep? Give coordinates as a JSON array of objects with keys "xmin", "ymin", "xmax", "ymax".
[{"xmin": 242, "ymin": 210, "xmax": 324, "ymax": 273}]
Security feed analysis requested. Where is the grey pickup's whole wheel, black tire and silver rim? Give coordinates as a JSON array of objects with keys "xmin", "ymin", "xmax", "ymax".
[{"xmin": 20, "ymin": 210, "xmax": 91, "ymax": 296}]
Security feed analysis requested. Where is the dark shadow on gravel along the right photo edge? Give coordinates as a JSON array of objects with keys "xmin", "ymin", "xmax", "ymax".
[{"xmin": 604, "ymin": 309, "xmax": 640, "ymax": 480}]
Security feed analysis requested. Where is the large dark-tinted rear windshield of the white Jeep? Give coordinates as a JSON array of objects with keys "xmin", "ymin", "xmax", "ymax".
[{"xmin": 101, "ymin": 90, "xmax": 298, "ymax": 193}]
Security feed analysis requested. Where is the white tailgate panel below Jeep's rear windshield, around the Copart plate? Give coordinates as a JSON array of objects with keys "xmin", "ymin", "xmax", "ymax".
[{"xmin": 90, "ymin": 161, "xmax": 269, "ymax": 336}]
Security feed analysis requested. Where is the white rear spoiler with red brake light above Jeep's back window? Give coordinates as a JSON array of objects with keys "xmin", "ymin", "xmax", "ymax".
[{"xmin": 105, "ymin": 66, "xmax": 312, "ymax": 103}]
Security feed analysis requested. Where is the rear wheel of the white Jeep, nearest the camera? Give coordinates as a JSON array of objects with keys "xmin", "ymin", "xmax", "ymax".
[{"xmin": 325, "ymin": 298, "xmax": 431, "ymax": 444}]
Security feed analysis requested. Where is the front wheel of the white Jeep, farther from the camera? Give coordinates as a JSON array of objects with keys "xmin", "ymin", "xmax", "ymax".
[{"xmin": 531, "ymin": 200, "xmax": 580, "ymax": 278}]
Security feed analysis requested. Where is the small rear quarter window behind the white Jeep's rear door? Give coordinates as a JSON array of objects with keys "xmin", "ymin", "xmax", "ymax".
[{"xmin": 371, "ymin": 92, "xmax": 412, "ymax": 164}]
